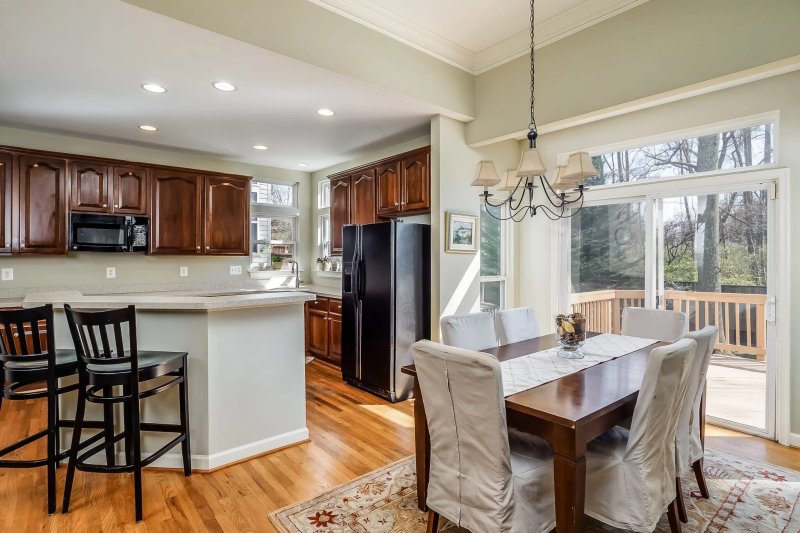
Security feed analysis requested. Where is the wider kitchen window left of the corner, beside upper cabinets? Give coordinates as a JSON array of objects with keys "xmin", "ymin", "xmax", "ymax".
[{"xmin": 250, "ymin": 181, "xmax": 299, "ymax": 270}]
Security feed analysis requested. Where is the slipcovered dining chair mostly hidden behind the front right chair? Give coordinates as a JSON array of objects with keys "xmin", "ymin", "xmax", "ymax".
[{"xmin": 675, "ymin": 326, "xmax": 719, "ymax": 522}]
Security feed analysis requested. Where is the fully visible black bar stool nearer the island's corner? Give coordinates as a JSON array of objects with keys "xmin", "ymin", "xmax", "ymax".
[{"xmin": 62, "ymin": 305, "xmax": 192, "ymax": 522}]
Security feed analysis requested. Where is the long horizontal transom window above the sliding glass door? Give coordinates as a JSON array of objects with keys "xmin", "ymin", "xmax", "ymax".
[{"xmin": 585, "ymin": 122, "xmax": 775, "ymax": 185}]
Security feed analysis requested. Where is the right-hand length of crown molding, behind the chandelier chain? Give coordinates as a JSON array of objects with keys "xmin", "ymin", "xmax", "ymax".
[{"xmin": 474, "ymin": 0, "xmax": 648, "ymax": 74}]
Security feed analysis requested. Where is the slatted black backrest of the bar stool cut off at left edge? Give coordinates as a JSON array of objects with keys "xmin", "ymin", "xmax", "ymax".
[{"xmin": 0, "ymin": 304, "xmax": 55, "ymax": 364}]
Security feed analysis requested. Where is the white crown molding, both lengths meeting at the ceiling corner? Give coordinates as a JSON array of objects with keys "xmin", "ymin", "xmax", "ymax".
[{"xmin": 308, "ymin": 0, "xmax": 648, "ymax": 74}]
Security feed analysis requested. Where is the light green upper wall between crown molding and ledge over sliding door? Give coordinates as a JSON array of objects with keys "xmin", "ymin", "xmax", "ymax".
[{"xmin": 467, "ymin": 0, "xmax": 800, "ymax": 144}]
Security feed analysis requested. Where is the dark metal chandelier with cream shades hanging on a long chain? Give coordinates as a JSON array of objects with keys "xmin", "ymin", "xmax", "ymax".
[{"xmin": 471, "ymin": 0, "xmax": 598, "ymax": 222}]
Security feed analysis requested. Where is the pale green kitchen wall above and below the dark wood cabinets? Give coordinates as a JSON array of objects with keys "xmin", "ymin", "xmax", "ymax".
[{"xmin": 0, "ymin": 127, "xmax": 311, "ymax": 295}]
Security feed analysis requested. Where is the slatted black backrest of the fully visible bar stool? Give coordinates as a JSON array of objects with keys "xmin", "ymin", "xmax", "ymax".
[{"xmin": 64, "ymin": 304, "xmax": 138, "ymax": 374}]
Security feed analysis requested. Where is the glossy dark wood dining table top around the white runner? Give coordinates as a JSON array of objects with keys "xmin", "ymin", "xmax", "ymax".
[{"xmin": 402, "ymin": 333, "xmax": 666, "ymax": 427}]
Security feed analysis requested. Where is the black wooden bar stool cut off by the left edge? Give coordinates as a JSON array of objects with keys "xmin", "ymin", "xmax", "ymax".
[{"xmin": 0, "ymin": 305, "xmax": 112, "ymax": 514}]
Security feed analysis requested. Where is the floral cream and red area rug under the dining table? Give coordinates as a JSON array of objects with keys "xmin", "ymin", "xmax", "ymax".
[{"xmin": 269, "ymin": 449, "xmax": 800, "ymax": 533}]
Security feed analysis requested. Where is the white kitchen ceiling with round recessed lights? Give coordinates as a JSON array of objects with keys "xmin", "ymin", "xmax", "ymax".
[{"xmin": 0, "ymin": 0, "xmax": 441, "ymax": 171}]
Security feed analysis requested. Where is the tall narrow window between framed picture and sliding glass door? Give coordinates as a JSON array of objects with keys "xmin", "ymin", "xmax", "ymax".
[{"xmin": 480, "ymin": 205, "xmax": 507, "ymax": 311}]
